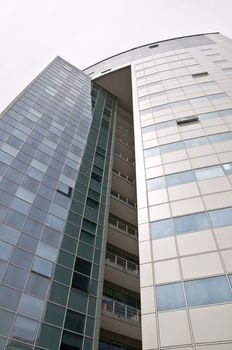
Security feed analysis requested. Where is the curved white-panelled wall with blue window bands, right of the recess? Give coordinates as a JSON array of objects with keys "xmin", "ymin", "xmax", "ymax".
[{"xmin": 132, "ymin": 35, "xmax": 232, "ymax": 350}]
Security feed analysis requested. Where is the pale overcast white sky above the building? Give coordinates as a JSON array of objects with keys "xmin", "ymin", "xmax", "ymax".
[{"xmin": 0, "ymin": 0, "xmax": 232, "ymax": 111}]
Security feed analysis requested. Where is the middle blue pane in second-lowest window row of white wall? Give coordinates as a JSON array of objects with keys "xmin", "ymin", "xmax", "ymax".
[{"xmin": 173, "ymin": 213, "xmax": 209, "ymax": 234}]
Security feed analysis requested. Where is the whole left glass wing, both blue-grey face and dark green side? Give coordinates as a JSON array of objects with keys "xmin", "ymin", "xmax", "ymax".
[{"xmin": 0, "ymin": 58, "xmax": 116, "ymax": 349}]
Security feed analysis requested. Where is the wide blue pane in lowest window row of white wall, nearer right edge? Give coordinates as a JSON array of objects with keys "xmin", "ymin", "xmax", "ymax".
[{"xmin": 185, "ymin": 276, "xmax": 232, "ymax": 306}]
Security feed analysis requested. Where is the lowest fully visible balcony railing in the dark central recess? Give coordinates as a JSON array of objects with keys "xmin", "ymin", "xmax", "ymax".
[{"xmin": 102, "ymin": 296, "xmax": 140, "ymax": 325}]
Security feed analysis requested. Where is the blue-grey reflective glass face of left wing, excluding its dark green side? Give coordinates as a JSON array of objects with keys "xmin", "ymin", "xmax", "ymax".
[{"xmin": 0, "ymin": 57, "xmax": 92, "ymax": 349}]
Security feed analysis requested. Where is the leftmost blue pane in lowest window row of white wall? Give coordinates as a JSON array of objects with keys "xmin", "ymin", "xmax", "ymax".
[{"xmin": 155, "ymin": 282, "xmax": 186, "ymax": 311}]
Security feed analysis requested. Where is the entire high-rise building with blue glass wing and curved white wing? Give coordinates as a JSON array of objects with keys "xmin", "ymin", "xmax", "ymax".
[{"xmin": 0, "ymin": 33, "xmax": 232, "ymax": 350}]
